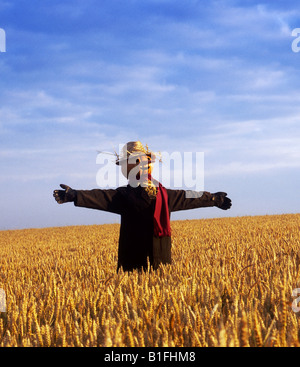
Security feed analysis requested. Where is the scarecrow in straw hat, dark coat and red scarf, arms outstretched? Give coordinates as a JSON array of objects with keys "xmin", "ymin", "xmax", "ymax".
[{"xmin": 53, "ymin": 141, "xmax": 231, "ymax": 271}]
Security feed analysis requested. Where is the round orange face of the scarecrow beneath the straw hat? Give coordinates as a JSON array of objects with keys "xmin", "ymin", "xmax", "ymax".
[{"xmin": 121, "ymin": 154, "xmax": 153, "ymax": 181}]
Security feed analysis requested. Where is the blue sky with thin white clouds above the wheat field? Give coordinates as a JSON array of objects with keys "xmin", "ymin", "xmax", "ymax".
[{"xmin": 0, "ymin": 0, "xmax": 300, "ymax": 229}]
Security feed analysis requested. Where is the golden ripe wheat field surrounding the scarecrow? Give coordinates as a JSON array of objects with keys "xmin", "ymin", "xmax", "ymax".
[{"xmin": 0, "ymin": 214, "xmax": 300, "ymax": 347}]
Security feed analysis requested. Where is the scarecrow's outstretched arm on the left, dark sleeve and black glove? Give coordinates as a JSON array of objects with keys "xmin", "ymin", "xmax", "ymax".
[{"xmin": 53, "ymin": 185, "xmax": 122, "ymax": 214}]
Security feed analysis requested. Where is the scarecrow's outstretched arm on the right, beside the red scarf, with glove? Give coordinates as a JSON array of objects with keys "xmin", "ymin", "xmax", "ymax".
[{"xmin": 167, "ymin": 189, "xmax": 231, "ymax": 212}]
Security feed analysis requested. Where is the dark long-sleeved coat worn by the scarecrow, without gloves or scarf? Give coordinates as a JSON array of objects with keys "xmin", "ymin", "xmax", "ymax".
[{"xmin": 74, "ymin": 185, "xmax": 214, "ymax": 271}]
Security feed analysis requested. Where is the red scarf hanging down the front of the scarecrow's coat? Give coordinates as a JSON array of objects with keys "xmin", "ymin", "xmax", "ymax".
[{"xmin": 153, "ymin": 183, "xmax": 171, "ymax": 237}]
